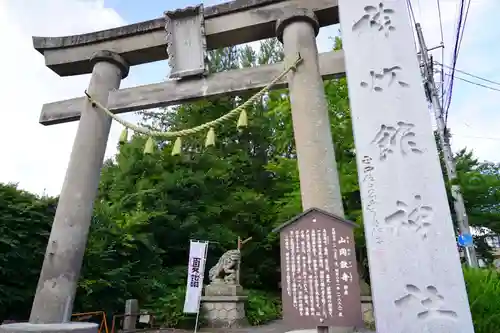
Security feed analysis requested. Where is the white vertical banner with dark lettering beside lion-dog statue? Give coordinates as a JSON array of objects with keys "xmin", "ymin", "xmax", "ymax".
[{"xmin": 184, "ymin": 241, "xmax": 208, "ymax": 313}]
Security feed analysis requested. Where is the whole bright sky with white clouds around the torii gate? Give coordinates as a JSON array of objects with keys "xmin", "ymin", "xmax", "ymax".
[{"xmin": 0, "ymin": 0, "xmax": 500, "ymax": 195}]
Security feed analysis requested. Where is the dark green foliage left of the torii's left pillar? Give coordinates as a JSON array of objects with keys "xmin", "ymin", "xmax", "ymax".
[{"xmin": 0, "ymin": 184, "xmax": 57, "ymax": 321}]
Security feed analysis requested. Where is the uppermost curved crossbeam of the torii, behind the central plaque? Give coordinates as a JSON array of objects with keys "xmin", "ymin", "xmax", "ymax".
[{"xmin": 33, "ymin": 0, "xmax": 339, "ymax": 76}]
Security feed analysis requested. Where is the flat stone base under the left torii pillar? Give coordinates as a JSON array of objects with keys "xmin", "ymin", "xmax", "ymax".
[{"xmin": 0, "ymin": 323, "xmax": 98, "ymax": 333}]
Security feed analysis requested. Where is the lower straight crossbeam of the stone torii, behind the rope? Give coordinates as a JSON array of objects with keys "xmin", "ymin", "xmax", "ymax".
[{"xmin": 40, "ymin": 51, "xmax": 345, "ymax": 125}]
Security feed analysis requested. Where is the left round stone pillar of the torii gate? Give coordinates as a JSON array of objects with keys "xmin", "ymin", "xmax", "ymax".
[{"xmin": 30, "ymin": 51, "xmax": 129, "ymax": 323}]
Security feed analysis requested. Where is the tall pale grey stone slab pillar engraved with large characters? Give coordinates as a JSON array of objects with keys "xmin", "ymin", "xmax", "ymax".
[{"xmin": 339, "ymin": 0, "xmax": 474, "ymax": 333}]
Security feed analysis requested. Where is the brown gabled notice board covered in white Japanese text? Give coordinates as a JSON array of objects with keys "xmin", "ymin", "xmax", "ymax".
[{"xmin": 274, "ymin": 208, "xmax": 364, "ymax": 330}]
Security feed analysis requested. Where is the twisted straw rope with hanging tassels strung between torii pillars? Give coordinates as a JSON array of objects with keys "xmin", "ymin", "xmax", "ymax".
[{"xmin": 85, "ymin": 54, "xmax": 303, "ymax": 156}]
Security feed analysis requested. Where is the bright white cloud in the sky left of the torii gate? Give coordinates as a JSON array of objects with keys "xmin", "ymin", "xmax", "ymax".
[{"xmin": 0, "ymin": 0, "xmax": 137, "ymax": 195}]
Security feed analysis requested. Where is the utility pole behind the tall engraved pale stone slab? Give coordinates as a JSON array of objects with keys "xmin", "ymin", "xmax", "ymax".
[{"xmin": 415, "ymin": 23, "xmax": 478, "ymax": 267}]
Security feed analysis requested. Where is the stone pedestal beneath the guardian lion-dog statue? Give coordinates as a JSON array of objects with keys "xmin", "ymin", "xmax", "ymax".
[{"xmin": 201, "ymin": 296, "xmax": 248, "ymax": 328}]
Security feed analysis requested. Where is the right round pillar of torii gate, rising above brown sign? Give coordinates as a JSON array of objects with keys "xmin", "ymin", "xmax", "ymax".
[{"xmin": 276, "ymin": 10, "xmax": 344, "ymax": 217}]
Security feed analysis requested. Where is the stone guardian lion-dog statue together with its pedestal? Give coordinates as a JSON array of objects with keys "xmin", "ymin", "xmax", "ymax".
[{"xmin": 201, "ymin": 249, "xmax": 248, "ymax": 328}]
